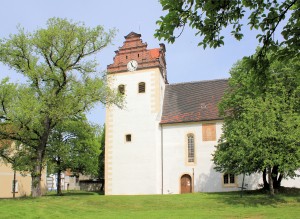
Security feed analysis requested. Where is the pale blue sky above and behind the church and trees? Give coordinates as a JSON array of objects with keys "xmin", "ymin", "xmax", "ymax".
[{"xmin": 0, "ymin": 0, "xmax": 257, "ymax": 124}]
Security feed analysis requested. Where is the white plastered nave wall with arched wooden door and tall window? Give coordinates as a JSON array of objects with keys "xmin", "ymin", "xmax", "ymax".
[{"xmin": 163, "ymin": 121, "xmax": 258, "ymax": 194}]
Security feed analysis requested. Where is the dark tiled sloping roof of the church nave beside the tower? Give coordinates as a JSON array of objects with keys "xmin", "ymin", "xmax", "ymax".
[{"xmin": 161, "ymin": 79, "xmax": 228, "ymax": 124}]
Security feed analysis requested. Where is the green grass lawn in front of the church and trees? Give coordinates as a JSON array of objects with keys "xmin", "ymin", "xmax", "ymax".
[{"xmin": 0, "ymin": 191, "xmax": 300, "ymax": 219}]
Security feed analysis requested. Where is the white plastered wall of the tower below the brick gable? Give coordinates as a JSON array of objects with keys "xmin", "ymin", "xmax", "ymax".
[{"xmin": 105, "ymin": 69, "xmax": 165, "ymax": 195}]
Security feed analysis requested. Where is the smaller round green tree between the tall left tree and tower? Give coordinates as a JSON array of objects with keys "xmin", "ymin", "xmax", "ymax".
[{"xmin": 46, "ymin": 115, "xmax": 101, "ymax": 195}]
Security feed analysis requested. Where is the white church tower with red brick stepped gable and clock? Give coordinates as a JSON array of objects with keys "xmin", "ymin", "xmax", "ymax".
[{"xmin": 105, "ymin": 32, "xmax": 167, "ymax": 195}]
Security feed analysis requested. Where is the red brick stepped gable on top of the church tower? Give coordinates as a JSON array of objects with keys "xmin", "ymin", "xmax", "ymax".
[{"xmin": 107, "ymin": 32, "xmax": 166, "ymax": 79}]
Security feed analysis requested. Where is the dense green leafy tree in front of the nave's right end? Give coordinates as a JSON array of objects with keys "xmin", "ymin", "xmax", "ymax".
[{"xmin": 213, "ymin": 51, "xmax": 300, "ymax": 194}]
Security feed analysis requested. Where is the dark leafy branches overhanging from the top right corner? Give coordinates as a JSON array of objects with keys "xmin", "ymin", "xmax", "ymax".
[{"xmin": 155, "ymin": 0, "xmax": 300, "ymax": 58}]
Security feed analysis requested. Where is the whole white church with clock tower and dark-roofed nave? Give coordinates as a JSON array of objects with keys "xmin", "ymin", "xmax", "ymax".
[{"xmin": 105, "ymin": 32, "xmax": 293, "ymax": 195}]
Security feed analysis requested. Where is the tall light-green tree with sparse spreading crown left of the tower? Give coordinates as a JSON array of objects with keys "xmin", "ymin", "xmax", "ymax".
[{"xmin": 0, "ymin": 18, "xmax": 119, "ymax": 197}]
